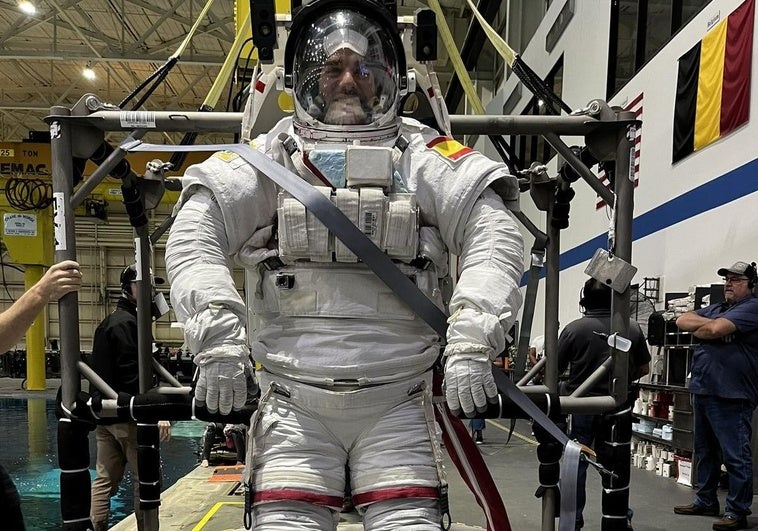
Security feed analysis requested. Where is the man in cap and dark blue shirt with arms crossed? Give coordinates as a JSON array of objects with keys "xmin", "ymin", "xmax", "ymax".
[{"xmin": 674, "ymin": 262, "xmax": 758, "ymax": 531}]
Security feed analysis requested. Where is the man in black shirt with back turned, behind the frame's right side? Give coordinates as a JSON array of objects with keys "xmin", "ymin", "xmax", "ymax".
[{"xmin": 558, "ymin": 278, "xmax": 650, "ymax": 529}]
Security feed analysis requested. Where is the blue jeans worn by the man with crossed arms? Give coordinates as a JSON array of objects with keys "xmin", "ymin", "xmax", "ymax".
[{"xmin": 692, "ymin": 395, "xmax": 753, "ymax": 517}]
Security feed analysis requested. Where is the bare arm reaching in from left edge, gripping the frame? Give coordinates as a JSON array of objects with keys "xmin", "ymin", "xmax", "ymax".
[{"xmin": 0, "ymin": 260, "xmax": 82, "ymax": 352}]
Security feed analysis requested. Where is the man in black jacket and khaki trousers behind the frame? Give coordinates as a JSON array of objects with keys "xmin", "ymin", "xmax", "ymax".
[{"xmin": 91, "ymin": 264, "xmax": 171, "ymax": 531}]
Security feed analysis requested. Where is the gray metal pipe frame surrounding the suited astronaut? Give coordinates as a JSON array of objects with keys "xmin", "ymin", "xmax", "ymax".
[{"xmin": 46, "ymin": 101, "xmax": 637, "ymax": 531}]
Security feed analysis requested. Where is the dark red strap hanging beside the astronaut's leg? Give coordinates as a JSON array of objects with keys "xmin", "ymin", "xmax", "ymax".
[{"xmin": 434, "ymin": 402, "xmax": 511, "ymax": 531}]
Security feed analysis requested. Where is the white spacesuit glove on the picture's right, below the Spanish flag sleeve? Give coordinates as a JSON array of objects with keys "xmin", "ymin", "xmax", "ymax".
[{"xmin": 445, "ymin": 352, "xmax": 497, "ymax": 418}]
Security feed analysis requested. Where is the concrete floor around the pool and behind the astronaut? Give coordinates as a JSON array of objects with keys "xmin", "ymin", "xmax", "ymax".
[{"xmin": 113, "ymin": 420, "xmax": 758, "ymax": 531}]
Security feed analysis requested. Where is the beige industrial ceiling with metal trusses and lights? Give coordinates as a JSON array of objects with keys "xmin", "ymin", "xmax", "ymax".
[{"xmin": 0, "ymin": 0, "xmax": 500, "ymax": 143}]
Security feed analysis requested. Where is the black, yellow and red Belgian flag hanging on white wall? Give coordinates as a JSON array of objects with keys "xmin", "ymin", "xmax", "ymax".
[{"xmin": 672, "ymin": 0, "xmax": 755, "ymax": 163}]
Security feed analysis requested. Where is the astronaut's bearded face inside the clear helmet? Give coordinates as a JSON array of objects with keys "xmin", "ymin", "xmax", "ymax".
[{"xmin": 319, "ymin": 48, "xmax": 377, "ymax": 125}]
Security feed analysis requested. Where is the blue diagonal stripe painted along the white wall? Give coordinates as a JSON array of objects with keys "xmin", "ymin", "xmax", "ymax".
[{"xmin": 521, "ymin": 159, "xmax": 758, "ymax": 286}]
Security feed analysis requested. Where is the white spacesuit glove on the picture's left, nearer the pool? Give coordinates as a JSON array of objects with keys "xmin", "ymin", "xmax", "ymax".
[{"xmin": 195, "ymin": 358, "xmax": 247, "ymax": 415}]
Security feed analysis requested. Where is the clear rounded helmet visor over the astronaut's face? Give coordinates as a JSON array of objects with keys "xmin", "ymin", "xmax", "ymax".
[{"xmin": 293, "ymin": 10, "xmax": 399, "ymax": 129}]
